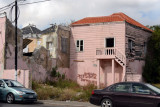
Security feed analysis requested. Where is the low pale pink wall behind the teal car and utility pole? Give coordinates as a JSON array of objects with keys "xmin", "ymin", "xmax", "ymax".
[{"xmin": 3, "ymin": 69, "xmax": 30, "ymax": 88}]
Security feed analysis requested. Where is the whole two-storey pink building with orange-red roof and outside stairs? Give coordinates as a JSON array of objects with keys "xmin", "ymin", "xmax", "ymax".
[{"xmin": 69, "ymin": 13, "xmax": 152, "ymax": 87}]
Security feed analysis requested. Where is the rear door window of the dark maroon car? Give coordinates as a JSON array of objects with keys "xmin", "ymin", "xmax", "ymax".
[{"xmin": 114, "ymin": 84, "xmax": 131, "ymax": 92}]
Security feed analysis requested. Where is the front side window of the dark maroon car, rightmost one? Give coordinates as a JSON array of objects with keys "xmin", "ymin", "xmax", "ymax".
[{"xmin": 132, "ymin": 84, "xmax": 151, "ymax": 94}]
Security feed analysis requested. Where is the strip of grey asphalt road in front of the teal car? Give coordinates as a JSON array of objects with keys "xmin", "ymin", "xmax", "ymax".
[{"xmin": 0, "ymin": 102, "xmax": 64, "ymax": 107}]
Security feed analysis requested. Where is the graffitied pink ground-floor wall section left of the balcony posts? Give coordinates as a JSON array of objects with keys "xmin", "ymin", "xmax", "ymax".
[{"xmin": 69, "ymin": 60, "xmax": 99, "ymax": 86}]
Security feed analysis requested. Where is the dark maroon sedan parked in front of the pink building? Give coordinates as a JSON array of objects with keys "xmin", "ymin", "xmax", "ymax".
[{"xmin": 90, "ymin": 82, "xmax": 160, "ymax": 107}]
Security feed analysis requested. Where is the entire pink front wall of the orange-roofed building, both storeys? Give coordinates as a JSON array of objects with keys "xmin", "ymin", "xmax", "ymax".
[{"xmin": 70, "ymin": 22, "xmax": 125, "ymax": 85}]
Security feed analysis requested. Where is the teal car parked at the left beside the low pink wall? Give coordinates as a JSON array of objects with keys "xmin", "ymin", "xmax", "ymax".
[{"xmin": 0, "ymin": 79, "xmax": 37, "ymax": 103}]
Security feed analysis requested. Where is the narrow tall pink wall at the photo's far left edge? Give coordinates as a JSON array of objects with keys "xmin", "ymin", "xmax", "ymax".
[{"xmin": 0, "ymin": 17, "xmax": 6, "ymax": 78}]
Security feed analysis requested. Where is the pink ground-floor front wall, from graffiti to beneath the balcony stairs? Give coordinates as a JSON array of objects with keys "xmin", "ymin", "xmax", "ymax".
[{"xmin": 69, "ymin": 59, "xmax": 123, "ymax": 87}]
